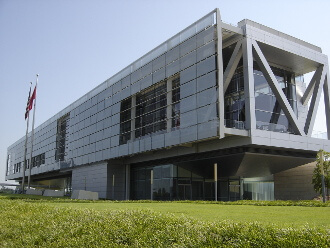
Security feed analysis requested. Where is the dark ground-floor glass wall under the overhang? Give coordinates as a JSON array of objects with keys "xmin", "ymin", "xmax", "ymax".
[{"xmin": 130, "ymin": 163, "xmax": 241, "ymax": 201}]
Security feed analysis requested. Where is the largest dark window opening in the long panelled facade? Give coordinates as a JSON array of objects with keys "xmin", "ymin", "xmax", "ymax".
[{"xmin": 119, "ymin": 76, "xmax": 180, "ymax": 145}]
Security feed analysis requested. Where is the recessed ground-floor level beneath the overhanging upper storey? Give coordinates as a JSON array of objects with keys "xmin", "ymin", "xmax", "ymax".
[{"xmin": 72, "ymin": 150, "xmax": 316, "ymax": 201}]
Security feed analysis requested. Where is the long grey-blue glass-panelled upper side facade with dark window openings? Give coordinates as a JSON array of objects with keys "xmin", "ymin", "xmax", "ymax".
[{"xmin": 8, "ymin": 12, "xmax": 218, "ymax": 179}]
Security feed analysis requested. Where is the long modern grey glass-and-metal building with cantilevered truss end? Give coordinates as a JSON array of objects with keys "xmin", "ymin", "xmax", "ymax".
[{"xmin": 6, "ymin": 9, "xmax": 330, "ymax": 201}]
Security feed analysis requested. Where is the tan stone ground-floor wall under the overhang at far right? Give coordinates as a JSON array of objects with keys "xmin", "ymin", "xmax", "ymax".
[{"xmin": 274, "ymin": 162, "xmax": 317, "ymax": 200}]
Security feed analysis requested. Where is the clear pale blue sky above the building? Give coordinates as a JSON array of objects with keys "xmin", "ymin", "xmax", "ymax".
[{"xmin": 0, "ymin": 0, "xmax": 330, "ymax": 182}]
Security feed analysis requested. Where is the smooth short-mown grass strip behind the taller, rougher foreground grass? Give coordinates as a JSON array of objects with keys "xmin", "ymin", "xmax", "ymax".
[{"xmin": 48, "ymin": 201, "xmax": 330, "ymax": 228}]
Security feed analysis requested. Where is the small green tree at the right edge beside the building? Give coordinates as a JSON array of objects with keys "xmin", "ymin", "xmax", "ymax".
[{"xmin": 312, "ymin": 150, "xmax": 330, "ymax": 200}]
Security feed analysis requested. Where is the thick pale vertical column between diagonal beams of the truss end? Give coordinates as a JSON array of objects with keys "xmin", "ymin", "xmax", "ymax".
[{"xmin": 242, "ymin": 36, "xmax": 256, "ymax": 136}]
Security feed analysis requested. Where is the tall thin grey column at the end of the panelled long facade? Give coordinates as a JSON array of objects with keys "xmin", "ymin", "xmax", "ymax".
[{"xmin": 216, "ymin": 8, "xmax": 225, "ymax": 139}]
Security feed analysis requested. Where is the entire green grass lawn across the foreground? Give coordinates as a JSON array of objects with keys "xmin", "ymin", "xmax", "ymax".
[{"xmin": 0, "ymin": 194, "xmax": 330, "ymax": 248}]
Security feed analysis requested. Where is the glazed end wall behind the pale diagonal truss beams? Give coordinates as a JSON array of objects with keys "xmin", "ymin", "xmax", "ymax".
[{"xmin": 223, "ymin": 46, "xmax": 298, "ymax": 133}]
